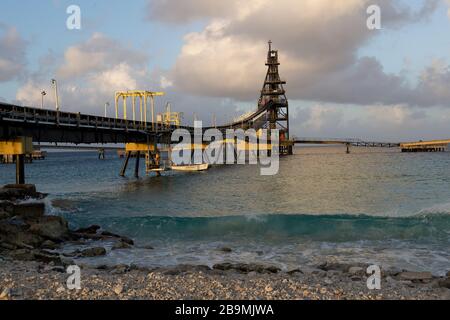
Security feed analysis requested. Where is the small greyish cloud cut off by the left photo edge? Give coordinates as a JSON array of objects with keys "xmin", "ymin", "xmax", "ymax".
[{"xmin": 0, "ymin": 24, "xmax": 27, "ymax": 82}]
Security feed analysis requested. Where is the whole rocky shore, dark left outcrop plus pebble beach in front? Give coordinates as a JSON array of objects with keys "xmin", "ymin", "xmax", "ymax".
[{"xmin": 0, "ymin": 185, "xmax": 450, "ymax": 300}]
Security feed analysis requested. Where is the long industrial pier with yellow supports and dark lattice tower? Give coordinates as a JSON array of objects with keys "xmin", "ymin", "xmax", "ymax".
[{"xmin": 0, "ymin": 42, "xmax": 450, "ymax": 184}]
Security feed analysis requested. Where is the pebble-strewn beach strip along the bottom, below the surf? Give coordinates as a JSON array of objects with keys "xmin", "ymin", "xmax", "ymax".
[{"xmin": 0, "ymin": 258, "xmax": 450, "ymax": 300}]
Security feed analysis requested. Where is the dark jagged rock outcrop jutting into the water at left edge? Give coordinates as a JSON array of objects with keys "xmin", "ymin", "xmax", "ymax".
[{"xmin": 0, "ymin": 185, "xmax": 134, "ymax": 265}]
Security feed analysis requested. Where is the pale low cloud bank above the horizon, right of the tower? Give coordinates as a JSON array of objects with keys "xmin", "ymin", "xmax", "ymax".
[{"xmin": 291, "ymin": 103, "xmax": 450, "ymax": 142}]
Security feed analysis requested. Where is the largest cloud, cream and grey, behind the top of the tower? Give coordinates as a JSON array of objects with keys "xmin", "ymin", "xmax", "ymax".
[{"xmin": 156, "ymin": 0, "xmax": 450, "ymax": 106}]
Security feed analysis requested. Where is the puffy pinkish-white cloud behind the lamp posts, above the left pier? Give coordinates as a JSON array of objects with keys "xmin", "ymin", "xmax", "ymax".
[{"xmin": 16, "ymin": 33, "xmax": 151, "ymax": 114}]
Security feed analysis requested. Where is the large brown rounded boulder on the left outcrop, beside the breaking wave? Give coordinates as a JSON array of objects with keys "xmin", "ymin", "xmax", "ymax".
[{"xmin": 30, "ymin": 216, "xmax": 69, "ymax": 242}]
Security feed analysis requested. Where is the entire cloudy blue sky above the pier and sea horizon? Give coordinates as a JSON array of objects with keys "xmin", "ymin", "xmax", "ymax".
[{"xmin": 0, "ymin": 0, "xmax": 450, "ymax": 141}]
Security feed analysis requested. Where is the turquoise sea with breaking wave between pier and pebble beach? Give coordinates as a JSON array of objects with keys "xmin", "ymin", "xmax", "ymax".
[{"xmin": 0, "ymin": 147, "xmax": 450, "ymax": 274}]
